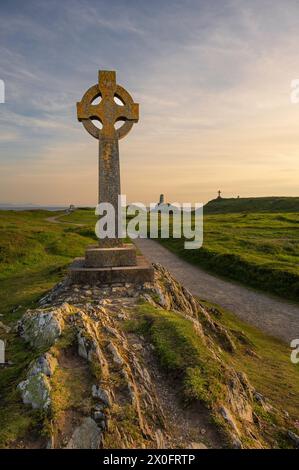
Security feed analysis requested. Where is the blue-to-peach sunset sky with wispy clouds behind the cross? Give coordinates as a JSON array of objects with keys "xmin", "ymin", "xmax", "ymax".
[{"xmin": 0, "ymin": 0, "xmax": 299, "ymax": 205}]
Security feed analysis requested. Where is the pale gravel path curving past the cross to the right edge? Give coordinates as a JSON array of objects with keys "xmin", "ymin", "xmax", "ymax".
[{"xmin": 135, "ymin": 239, "xmax": 299, "ymax": 342}]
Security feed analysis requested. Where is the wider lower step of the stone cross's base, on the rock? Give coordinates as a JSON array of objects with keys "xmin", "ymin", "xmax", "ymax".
[{"xmin": 69, "ymin": 256, "xmax": 154, "ymax": 285}]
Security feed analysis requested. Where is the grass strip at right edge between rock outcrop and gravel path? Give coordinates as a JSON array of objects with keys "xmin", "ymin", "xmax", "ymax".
[{"xmin": 200, "ymin": 301, "xmax": 299, "ymax": 419}]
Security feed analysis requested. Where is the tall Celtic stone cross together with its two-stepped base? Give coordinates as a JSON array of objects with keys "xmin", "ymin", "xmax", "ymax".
[{"xmin": 69, "ymin": 70, "xmax": 154, "ymax": 284}]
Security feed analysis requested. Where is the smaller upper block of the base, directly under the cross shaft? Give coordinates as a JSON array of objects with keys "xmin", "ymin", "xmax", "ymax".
[{"xmin": 85, "ymin": 244, "xmax": 136, "ymax": 268}]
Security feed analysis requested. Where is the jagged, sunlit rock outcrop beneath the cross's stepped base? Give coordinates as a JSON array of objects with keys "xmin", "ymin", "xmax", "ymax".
[{"xmin": 17, "ymin": 265, "xmax": 294, "ymax": 448}]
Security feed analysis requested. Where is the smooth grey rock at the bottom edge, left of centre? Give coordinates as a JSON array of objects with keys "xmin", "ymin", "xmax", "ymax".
[{"xmin": 66, "ymin": 417, "xmax": 102, "ymax": 449}]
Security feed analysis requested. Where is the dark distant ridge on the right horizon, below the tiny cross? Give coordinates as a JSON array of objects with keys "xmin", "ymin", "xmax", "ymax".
[{"xmin": 204, "ymin": 196, "xmax": 299, "ymax": 214}]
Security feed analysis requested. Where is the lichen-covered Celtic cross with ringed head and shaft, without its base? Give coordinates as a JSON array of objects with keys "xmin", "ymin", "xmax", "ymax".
[{"xmin": 77, "ymin": 70, "xmax": 139, "ymax": 246}]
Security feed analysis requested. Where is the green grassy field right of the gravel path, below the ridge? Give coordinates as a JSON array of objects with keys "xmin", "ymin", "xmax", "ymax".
[{"xmin": 159, "ymin": 212, "xmax": 299, "ymax": 300}]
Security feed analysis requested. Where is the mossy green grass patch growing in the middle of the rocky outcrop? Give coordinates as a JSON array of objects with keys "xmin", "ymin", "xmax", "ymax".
[{"xmin": 127, "ymin": 304, "xmax": 221, "ymax": 405}]
